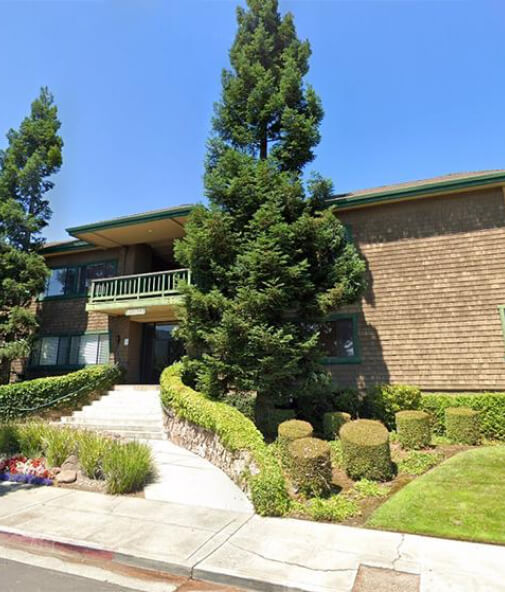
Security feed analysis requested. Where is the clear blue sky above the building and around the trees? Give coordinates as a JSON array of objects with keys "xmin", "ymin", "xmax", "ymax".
[{"xmin": 0, "ymin": 0, "xmax": 505, "ymax": 240}]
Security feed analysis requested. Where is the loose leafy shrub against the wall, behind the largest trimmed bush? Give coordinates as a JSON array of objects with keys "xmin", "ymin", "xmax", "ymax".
[{"xmin": 363, "ymin": 384, "xmax": 421, "ymax": 429}]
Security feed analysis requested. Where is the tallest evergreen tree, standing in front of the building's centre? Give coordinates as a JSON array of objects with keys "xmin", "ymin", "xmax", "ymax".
[{"xmin": 175, "ymin": 0, "xmax": 364, "ymax": 412}]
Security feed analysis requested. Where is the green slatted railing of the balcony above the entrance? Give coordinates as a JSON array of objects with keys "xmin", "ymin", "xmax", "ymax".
[{"xmin": 88, "ymin": 269, "xmax": 191, "ymax": 304}]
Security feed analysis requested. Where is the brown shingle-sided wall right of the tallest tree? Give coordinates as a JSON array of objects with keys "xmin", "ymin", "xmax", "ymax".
[{"xmin": 332, "ymin": 188, "xmax": 505, "ymax": 390}]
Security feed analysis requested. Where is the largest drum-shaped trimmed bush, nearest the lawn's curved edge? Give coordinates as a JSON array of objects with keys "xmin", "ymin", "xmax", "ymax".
[{"xmin": 340, "ymin": 419, "xmax": 393, "ymax": 481}]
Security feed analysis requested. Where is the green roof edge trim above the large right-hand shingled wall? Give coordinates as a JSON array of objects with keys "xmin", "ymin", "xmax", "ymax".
[{"xmin": 328, "ymin": 171, "xmax": 505, "ymax": 208}]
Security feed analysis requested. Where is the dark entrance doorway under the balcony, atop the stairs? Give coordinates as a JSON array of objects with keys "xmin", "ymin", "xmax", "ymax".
[{"xmin": 141, "ymin": 323, "xmax": 184, "ymax": 384}]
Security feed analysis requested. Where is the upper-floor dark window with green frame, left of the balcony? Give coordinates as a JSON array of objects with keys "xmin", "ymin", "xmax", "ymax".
[{"xmin": 41, "ymin": 260, "xmax": 117, "ymax": 298}]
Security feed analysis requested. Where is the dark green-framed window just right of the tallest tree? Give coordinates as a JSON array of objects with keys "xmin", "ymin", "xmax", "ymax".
[{"xmin": 320, "ymin": 314, "xmax": 361, "ymax": 364}]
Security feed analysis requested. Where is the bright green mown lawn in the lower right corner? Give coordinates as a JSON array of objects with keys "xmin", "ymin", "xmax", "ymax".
[{"xmin": 366, "ymin": 446, "xmax": 505, "ymax": 543}]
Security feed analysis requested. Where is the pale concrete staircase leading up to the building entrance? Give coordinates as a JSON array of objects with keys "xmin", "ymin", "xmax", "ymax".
[{"xmin": 60, "ymin": 384, "xmax": 167, "ymax": 440}]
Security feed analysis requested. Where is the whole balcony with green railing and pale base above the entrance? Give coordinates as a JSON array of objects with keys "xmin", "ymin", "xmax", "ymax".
[{"xmin": 86, "ymin": 269, "xmax": 191, "ymax": 322}]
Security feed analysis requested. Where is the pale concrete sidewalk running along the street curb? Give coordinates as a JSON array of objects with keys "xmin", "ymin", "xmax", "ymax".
[{"xmin": 0, "ymin": 483, "xmax": 505, "ymax": 592}]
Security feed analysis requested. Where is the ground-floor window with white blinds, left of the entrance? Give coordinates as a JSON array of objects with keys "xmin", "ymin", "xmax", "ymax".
[{"xmin": 30, "ymin": 333, "xmax": 109, "ymax": 366}]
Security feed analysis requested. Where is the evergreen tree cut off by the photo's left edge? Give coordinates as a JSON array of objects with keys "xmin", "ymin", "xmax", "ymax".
[{"xmin": 0, "ymin": 88, "xmax": 63, "ymax": 382}]
